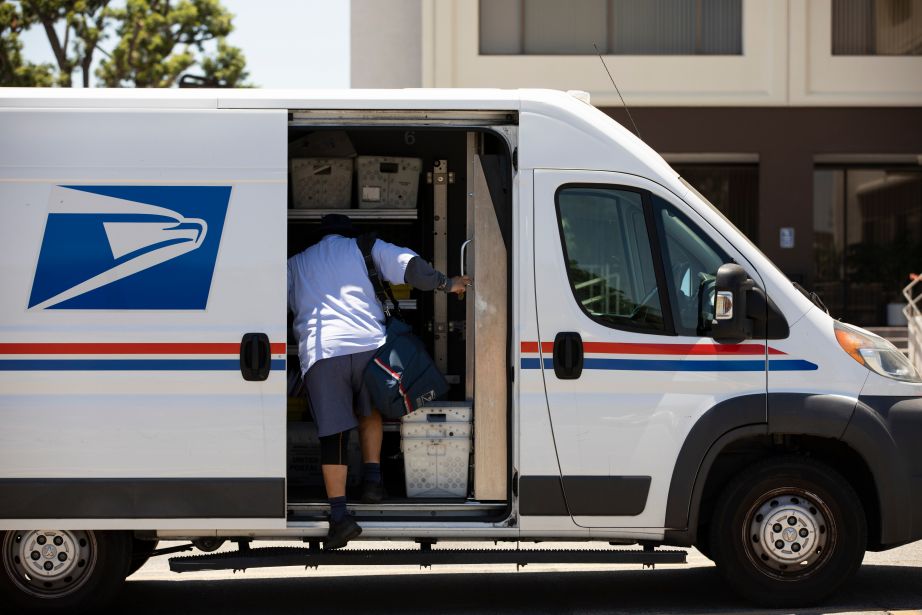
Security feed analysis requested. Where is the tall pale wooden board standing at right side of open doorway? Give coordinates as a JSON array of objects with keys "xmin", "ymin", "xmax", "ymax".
[{"xmin": 467, "ymin": 150, "xmax": 509, "ymax": 500}]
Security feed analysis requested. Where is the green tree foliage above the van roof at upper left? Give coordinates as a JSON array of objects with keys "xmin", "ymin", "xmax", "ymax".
[{"xmin": 0, "ymin": 0, "xmax": 248, "ymax": 87}]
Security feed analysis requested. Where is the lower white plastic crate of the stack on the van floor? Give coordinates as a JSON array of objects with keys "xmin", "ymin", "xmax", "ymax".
[{"xmin": 400, "ymin": 438, "xmax": 471, "ymax": 498}]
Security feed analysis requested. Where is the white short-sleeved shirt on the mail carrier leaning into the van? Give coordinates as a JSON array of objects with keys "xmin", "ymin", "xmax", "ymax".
[{"xmin": 288, "ymin": 235, "xmax": 417, "ymax": 374}]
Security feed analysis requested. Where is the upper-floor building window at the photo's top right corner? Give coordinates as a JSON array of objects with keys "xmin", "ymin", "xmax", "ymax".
[{"xmin": 832, "ymin": 0, "xmax": 922, "ymax": 56}]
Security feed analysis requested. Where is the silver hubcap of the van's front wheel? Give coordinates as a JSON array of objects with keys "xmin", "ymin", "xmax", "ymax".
[{"xmin": 743, "ymin": 489, "xmax": 835, "ymax": 576}]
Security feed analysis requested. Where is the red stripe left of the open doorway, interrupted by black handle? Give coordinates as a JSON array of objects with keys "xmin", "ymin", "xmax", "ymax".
[{"xmin": 0, "ymin": 342, "xmax": 287, "ymax": 354}]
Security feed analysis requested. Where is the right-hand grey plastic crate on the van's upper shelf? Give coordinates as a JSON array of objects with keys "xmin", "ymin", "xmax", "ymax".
[{"xmin": 355, "ymin": 156, "xmax": 423, "ymax": 209}]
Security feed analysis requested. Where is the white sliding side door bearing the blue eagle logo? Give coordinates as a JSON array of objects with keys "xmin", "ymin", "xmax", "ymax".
[{"xmin": 0, "ymin": 109, "xmax": 287, "ymax": 530}]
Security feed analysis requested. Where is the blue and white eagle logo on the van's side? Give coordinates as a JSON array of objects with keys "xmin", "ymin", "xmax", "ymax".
[{"xmin": 29, "ymin": 186, "xmax": 231, "ymax": 310}]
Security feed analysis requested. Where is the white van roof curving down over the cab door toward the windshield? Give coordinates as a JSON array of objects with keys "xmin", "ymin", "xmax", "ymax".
[{"xmin": 0, "ymin": 88, "xmax": 687, "ymax": 196}]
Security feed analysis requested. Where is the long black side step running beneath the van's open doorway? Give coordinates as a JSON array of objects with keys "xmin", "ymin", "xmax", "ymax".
[{"xmin": 170, "ymin": 547, "xmax": 687, "ymax": 572}]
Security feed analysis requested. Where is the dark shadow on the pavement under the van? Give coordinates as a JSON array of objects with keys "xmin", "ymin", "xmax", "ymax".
[{"xmin": 122, "ymin": 565, "xmax": 922, "ymax": 615}]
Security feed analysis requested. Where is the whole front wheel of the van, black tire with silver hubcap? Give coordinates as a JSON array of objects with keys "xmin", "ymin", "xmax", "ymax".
[{"xmin": 710, "ymin": 457, "xmax": 867, "ymax": 608}]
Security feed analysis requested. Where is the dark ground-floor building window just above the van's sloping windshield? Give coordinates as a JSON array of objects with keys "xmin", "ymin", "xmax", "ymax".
[{"xmin": 672, "ymin": 163, "xmax": 759, "ymax": 244}]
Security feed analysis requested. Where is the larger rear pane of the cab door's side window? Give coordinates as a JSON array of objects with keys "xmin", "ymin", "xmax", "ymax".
[{"xmin": 557, "ymin": 186, "xmax": 665, "ymax": 332}]
